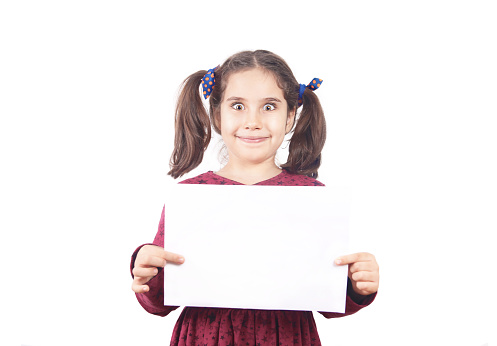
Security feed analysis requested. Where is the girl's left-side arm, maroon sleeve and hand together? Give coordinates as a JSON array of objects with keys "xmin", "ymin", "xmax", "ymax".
[{"xmin": 130, "ymin": 205, "xmax": 184, "ymax": 316}]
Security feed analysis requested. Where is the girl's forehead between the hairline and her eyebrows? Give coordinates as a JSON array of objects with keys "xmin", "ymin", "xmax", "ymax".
[{"xmin": 223, "ymin": 68, "xmax": 284, "ymax": 100}]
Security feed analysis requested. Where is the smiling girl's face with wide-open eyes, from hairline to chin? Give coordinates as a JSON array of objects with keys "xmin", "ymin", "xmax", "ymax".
[{"xmin": 220, "ymin": 68, "xmax": 294, "ymax": 168}]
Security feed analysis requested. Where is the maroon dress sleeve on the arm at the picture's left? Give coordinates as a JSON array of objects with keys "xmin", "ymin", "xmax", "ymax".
[{"xmin": 130, "ymin": 208, "xmax": 178, "ymax": 316}]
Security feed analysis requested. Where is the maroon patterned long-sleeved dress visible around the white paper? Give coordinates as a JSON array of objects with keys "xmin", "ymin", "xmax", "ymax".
[{"xmin": 131, "ymin": 170, "xmax": 376, "ymax": 346}]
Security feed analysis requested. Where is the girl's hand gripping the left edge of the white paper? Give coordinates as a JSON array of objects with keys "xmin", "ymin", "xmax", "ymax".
[{"xmin": 131, "ymin": 245, "xmax": 185, "ymax": 293}]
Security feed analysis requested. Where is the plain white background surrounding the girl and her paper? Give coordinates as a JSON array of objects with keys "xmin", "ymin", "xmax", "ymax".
[{"xmin": 0, "ymin": 0, "xmax": 497, "ymax": 346}]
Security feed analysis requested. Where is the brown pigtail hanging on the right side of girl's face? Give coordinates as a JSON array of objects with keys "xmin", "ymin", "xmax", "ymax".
[{"xmin": 281, "ymin": 88, "xmax": 326, "ymax": 178}]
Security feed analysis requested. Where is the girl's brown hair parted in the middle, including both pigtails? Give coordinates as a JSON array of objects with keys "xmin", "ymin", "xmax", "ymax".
[{"xmin": 168, "ymin": 50, "xmax": 326, "ymax": 178}]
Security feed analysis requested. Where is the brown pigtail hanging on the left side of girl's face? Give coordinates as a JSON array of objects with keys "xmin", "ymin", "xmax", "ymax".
[{"xmin": 167, "ymin": 71, "xmax": 211, "ymax": 179}]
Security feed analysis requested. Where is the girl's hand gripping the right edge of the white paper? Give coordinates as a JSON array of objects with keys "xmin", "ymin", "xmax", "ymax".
[{"xmin": 335, "ymin": 252, "xmax": 380, "ymax": 296}]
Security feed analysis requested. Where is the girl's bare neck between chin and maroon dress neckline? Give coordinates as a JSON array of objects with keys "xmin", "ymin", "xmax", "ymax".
[{"xmin": 216, "ymin": 161, "xmax": 281, "ymax": 185}]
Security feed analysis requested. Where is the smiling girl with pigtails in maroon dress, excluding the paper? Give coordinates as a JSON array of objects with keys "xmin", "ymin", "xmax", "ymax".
[{"xmin": 131, "ymin": 50, "xmax": 379, "ymax": 345}]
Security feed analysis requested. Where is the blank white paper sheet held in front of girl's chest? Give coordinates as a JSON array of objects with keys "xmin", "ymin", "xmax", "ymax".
[{"xmin": 164, "ymin": 184, "xmax": 349, "ymax": 313}]
